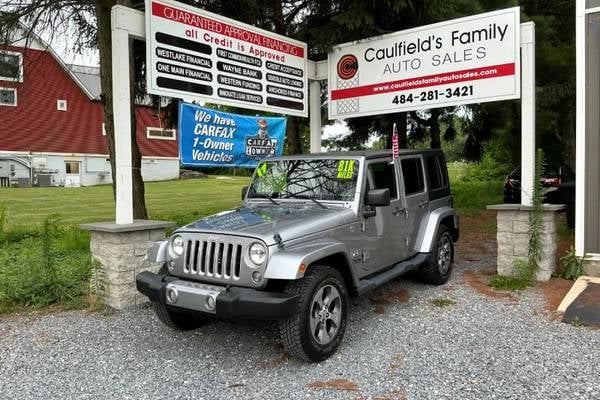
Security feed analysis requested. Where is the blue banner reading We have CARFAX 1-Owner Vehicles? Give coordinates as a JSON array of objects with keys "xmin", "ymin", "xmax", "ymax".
[{"xmin": 179, "ymin": 102, "xmax": 287, "ymax": 168}]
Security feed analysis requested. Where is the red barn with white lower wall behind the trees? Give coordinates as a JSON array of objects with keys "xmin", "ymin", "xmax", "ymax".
[{"xmin": 0, "ymin": 31, "xmax": 179, "ymax": 186}]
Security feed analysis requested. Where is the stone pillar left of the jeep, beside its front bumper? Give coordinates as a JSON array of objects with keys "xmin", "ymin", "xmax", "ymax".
[{"xmin": 80, "ymin": 220, "xmax": 175, "ymax": 310}]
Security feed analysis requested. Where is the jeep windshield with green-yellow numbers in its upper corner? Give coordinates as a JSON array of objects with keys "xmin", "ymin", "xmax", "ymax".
[{"xmin": 248, "ymin": 159, "xmax": 359, "ymax": 201}]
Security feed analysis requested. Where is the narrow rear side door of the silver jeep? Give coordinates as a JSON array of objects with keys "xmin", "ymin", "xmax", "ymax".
[{"xmin": 400, "ymin": 155, "xmax": 429, "ymax": 257}]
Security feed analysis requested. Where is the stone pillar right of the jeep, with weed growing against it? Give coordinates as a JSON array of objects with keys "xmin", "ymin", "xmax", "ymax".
[{"xmin": 487, "ymin": 204, "xmax": 565, "ymax": 281}]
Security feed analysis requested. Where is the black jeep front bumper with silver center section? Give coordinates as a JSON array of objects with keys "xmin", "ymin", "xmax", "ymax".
[{"xmin": 135, "ymin": 271, "xmax": 299, "ymax": 320}]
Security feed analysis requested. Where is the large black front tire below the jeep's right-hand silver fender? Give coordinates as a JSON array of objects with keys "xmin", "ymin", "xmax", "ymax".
[{"xmin": 279, "ymin": 265, "xmax": 348, "ymax": 362}]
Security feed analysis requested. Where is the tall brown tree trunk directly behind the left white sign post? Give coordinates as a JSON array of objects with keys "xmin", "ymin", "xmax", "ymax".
[{"xmin": 96, "ymin": 0, "xmax": 148, "ymax": 219}]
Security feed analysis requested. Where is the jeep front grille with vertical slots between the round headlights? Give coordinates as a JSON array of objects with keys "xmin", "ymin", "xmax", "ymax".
[{"xmin": 183, "ymin": 240, "xmax": 243, "ymax": 280}]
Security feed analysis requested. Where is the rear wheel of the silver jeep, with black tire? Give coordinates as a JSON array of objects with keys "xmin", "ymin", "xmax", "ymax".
[{"xmin": 419, "ymin": 225, "xmax": 454, "ymax": 285}]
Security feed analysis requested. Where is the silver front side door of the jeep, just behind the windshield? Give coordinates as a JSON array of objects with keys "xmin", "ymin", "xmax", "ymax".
[{"xmin": 364, "ymin": 158, "xmax": 406, "ymax": 272}]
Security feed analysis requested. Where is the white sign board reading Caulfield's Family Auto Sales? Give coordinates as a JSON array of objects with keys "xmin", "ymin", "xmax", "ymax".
[{"xmin": 328, "ymin": 7, "xmax": 521, "ymax": 119}]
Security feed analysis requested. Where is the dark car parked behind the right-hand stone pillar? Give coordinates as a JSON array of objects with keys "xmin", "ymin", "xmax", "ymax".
[{"xmin": 504, "ymin": 163, "xmax": 575, "ymax": 228}]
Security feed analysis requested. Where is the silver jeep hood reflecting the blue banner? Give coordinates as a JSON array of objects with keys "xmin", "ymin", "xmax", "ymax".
[{"xmin": 177, "ymin": 204, "xmax": 356, "ymax": 246}]
